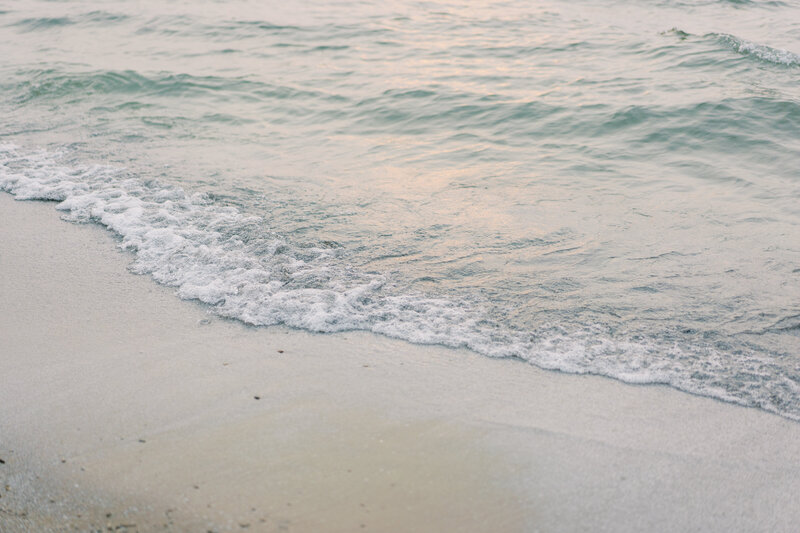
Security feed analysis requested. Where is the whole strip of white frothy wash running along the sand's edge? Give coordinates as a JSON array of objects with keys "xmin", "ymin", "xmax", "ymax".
[{"xmin": 0, "ymin": 145, "xmax": 800, "ymax": 420}]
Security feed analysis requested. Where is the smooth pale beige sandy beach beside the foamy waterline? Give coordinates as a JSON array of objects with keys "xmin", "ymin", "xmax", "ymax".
[{"xmin": 0, "ymin": 189, "xmax": 800, "ymax": 532}]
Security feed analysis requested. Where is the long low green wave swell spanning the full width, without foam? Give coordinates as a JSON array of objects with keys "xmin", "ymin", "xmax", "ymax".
[{"xmin": 9, "ymin": 61, "xmax": 800, "ymax": 160}]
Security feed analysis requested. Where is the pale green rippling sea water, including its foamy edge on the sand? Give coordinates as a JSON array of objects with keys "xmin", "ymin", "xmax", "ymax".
[{"xmin": 0, "ymin": 0, "xmax": 800, "ymax": 420}]
